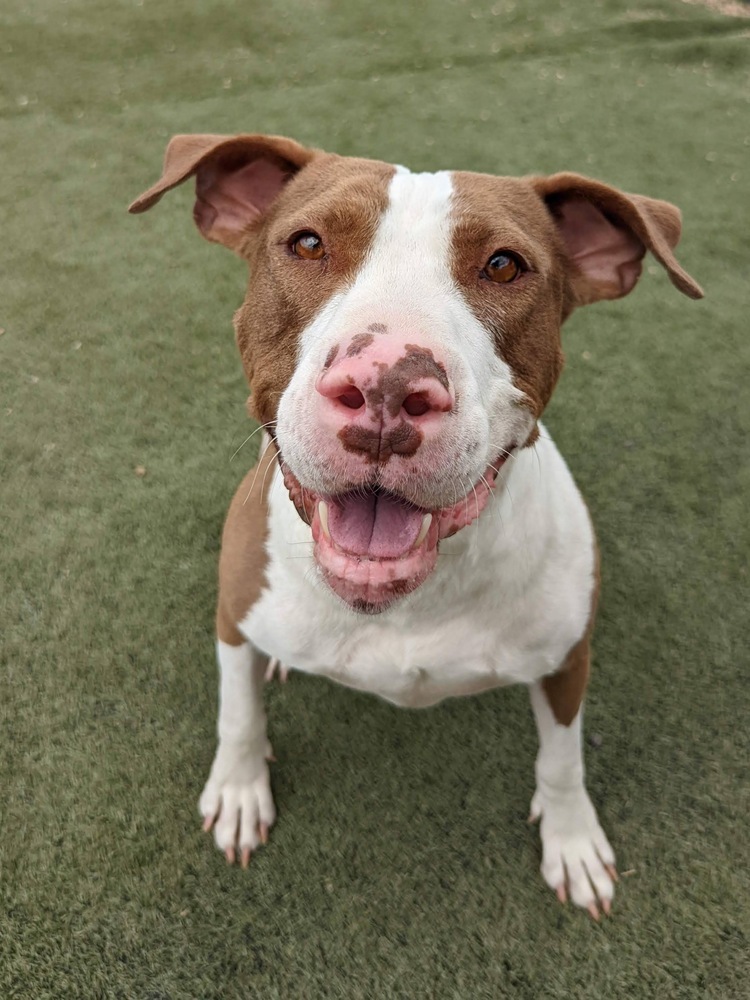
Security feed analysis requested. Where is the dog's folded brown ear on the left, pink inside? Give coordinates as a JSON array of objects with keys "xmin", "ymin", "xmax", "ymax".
[{"xmin": 128, "ymin": 135, "xmax": 317, "ymax": 252}]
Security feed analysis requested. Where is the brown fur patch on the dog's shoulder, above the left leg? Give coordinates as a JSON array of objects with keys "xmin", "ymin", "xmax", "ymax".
[{"xmin": 216, "ymin": 444, "xmax": 277, "ymax": 646}]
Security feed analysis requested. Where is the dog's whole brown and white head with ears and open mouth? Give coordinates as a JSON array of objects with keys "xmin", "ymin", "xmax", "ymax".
[{"xmin": 131, "ymin": 136, "xmax": 701, "ymax": 612}]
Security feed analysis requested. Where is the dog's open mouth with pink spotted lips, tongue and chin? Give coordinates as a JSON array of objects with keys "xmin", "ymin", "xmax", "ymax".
[{"xmin": 280, "ymin": 451, "xmax": 509, "ymax": 614}]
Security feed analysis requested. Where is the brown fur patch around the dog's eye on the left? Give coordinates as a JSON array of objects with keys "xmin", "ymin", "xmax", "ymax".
[{"xmin": 235, "ymin": 154, "xmax": 394, "ymax": 423}]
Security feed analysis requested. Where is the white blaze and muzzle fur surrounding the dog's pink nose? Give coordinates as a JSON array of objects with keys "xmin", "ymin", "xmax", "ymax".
[{"xmin": 277, "ymin": 167, "xmax": 532, "ymax": 507}]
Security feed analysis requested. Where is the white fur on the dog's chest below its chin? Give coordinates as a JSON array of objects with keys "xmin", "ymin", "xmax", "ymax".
[{"xmin": 241, "ymin": 431, "xmax": 595, "ymax": 707}]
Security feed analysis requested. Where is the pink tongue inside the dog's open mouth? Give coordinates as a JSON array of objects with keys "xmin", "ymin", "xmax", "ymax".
[{"xmin": 328, "ymin": 493, "xmax": 424, "ymax": 559}]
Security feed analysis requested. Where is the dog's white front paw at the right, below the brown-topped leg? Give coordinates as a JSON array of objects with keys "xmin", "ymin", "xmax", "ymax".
[{"xmin": 529, "ymin": 788, "xmax": 617, "ymax": 920}]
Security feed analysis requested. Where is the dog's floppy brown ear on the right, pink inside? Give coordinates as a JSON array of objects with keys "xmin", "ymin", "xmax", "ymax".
[{"xmin": 531, "ymin": 173, "xmax": 703, "ymax": 305}]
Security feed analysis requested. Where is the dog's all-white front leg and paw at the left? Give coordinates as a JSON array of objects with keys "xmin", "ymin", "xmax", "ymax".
[{"xmin": 199, "ymin": 640, "xmax": 276, "ymax": 868}]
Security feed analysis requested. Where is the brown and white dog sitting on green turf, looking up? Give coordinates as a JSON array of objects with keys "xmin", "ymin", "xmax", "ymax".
[{"xmin": 131, "ymin": 135, "xmax": 702, "ymax": 917}]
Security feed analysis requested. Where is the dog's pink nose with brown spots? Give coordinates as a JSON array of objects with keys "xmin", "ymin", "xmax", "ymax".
[{"xmin": 316, "ymin": 333, "xmax": 455, "ymax": 462}]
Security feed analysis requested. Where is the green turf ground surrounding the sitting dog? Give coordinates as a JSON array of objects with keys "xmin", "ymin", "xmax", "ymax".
[{"xmin": 0, "ymin": 0, "xmax": 750, "ymax": 1000}]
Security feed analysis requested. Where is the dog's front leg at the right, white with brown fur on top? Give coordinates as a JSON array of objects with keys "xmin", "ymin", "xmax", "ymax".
[{"xmin": 530, "ymin": 637, "xmax": 617, "ymax": 919}]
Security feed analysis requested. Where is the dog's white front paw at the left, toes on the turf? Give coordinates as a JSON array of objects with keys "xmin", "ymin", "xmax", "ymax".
[{"xmin": 198, "ymin": 744, "xmax": 276, "ymax": 868}]
